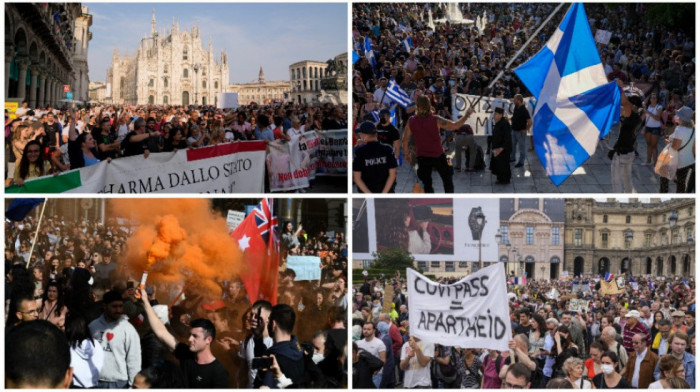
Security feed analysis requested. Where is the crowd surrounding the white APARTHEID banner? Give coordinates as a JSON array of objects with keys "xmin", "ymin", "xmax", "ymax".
[{"xmin": 351, "ymin": 271, "xmax": 696, "ymax": 389}]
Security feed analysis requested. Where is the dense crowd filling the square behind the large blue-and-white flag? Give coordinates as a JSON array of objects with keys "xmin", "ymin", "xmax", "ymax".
[{"xmin": 352, "ymin": 3, "xmax": 695, "ymax": 193}]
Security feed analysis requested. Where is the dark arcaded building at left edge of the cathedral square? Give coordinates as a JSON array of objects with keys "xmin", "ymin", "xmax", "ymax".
[{"xmin": 5, "ymin": 3, "xmax": 92, "ymax": 108}]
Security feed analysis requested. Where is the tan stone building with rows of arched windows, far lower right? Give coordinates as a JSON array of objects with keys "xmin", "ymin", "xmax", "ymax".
[{"xmin": 564, "ymin": 199, "xmax": 695, "ymax": 277}]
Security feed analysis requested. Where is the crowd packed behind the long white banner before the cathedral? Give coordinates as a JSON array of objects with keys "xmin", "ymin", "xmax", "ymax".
[{"xmin": 5, "ymin": 101, "xmax": 347, "ymax": 185}]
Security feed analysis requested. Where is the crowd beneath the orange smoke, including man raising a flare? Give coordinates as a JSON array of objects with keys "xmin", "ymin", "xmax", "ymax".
[{"xmin": 5, "ymin": 210, "xmax": 348, "ymax": 388}]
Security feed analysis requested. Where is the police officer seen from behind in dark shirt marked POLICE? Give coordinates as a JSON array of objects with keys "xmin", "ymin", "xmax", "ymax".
[{"xmin": 352, "ymin": 121, "xmax": 397, "ymax": 193}]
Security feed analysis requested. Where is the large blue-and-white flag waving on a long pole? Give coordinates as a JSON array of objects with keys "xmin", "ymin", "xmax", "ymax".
[{"xmin": 515, "ymin": 3, "xmax": 620, "ymax": 186}]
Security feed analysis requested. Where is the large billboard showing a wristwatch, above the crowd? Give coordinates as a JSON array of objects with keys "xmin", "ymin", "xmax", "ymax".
[{"xmin": 353, "ymin": 199, "xmax": 500, "ymax": 262}]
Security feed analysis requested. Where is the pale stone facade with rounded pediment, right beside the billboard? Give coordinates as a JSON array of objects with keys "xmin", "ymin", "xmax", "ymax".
[{"xmin": 498, "ymin": 199, "xmax": 564, "ymax": 279}]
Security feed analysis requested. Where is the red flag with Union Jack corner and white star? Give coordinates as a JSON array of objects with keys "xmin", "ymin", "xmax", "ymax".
[{"xmin": 231, "ymin": 199, "xmax": 279, "ymax": 305}]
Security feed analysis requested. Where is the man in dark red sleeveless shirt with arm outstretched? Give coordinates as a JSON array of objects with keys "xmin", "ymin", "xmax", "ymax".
[{"xmin": 403, "ymin": 95, "xmax": 474, "ymax": 193}]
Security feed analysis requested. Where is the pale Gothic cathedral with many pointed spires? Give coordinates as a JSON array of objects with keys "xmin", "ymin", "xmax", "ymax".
[{"xmin": 107, "ymin": 11, "xmax": 229, "ymax": 105}]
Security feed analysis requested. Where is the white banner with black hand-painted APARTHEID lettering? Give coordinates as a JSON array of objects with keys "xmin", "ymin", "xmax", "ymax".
[{"xmin": 406, "ymin": 263, "xmax": 512, "ymax": 351}]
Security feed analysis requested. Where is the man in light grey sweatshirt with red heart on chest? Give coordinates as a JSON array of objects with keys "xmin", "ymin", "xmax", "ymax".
[{"xmin": 89, "ymin": 291, "xmax": 141, "ymax": 389}]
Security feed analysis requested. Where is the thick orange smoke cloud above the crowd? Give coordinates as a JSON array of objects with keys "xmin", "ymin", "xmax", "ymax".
[{"xmin": 108, "ymin": 199, "xmax": 243, "ymax": 299}]
